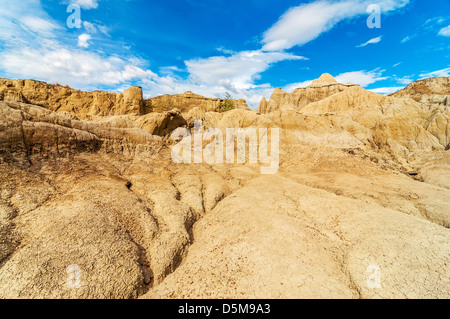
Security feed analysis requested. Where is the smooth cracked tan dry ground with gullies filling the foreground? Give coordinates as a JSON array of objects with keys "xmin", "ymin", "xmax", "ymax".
[{"xmin": 0, "ymin": 105, "xmax": 450, "ymax": 298}]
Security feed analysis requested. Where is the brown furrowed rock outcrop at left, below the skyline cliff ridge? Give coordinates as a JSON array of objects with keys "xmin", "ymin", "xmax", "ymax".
[{"xmin": 0, "ymin": 102, "xmax": 162, "ymax": 162}]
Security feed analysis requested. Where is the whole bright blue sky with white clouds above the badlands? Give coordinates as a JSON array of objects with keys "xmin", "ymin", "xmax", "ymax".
[{"xmin": 0, "ymin": 0, "xmax": 450, "ymax": 107}]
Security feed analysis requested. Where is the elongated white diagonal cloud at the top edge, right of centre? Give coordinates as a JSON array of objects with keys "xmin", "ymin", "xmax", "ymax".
[{"xmin": 262, "ymin": 0, "xmax": 409, "ymax": 51}]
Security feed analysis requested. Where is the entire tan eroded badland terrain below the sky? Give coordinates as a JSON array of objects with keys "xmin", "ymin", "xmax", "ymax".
[{"xmin": 0, "ymin": 74, "xmax": 450, "ymax": 298}]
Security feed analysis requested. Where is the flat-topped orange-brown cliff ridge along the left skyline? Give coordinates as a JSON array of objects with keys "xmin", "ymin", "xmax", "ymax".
[{"xmin": 0, "ymin": 78, "xmax": 249, "ymax": 119}]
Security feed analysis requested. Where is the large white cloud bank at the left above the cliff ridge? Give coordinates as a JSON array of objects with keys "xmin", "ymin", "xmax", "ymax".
[{"xmin": 0, "ymin": 0, "xmax": 156, "ymax": 89}]
